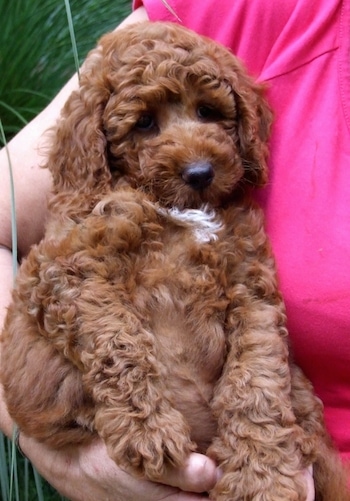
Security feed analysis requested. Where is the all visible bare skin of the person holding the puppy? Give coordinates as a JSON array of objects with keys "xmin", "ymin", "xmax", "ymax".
[{"xmin": 0, "ymin": 4, "xmax": 313, "ymax": 501}]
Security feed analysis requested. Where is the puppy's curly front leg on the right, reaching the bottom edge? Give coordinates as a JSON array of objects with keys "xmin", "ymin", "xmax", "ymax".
[{"xmin": 208, "ymin": 299, "xmax": 305, "ymax": 501}]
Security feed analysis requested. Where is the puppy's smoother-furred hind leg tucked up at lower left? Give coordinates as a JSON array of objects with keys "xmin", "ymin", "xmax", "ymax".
[{"xmin": 1, "ymin": 303, "xmax": 93, "ymax": 448}]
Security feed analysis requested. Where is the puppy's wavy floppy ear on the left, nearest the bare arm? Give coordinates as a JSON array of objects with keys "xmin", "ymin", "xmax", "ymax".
[{"xmin": 46, "ymin": 39, "xmax": 110, "ymax": 192}]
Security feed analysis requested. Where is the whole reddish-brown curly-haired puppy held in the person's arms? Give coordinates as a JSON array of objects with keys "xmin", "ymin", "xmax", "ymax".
[{"xmin": 1, "ymin": 23, "xmax": 350, "ymax": 501}]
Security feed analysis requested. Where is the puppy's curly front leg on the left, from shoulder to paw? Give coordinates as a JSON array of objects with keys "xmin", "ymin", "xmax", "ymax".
[{"xmin": 32, "ymin": 255, "xmax": 194, "ymax": 480}]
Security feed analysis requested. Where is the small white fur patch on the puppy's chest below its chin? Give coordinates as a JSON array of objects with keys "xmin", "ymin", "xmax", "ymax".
[{"xmin": 168, "ymin": 207, "xmax": 223, "ymax": 243}]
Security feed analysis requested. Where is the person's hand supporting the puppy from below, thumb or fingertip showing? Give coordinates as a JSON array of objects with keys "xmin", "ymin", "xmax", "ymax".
[{"xmin": 20, "ymin": 434, "xmax": 218, "ymax": 501}]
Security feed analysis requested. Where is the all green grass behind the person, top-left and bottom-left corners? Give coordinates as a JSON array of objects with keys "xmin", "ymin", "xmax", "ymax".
[{"xmin": 0, "ymin": 0, "xmax": 131, "ymax": 501}]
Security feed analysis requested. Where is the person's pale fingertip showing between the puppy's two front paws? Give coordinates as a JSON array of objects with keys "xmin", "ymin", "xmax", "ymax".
[{"xmin": 160, "ymin": 453, "xmax": 220, "ymax": 492}]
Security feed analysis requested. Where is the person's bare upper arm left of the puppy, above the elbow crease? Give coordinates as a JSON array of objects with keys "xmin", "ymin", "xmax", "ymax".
[{"xmin": 0, "ymin": 76, "xmax": 77, "ymax": 260}]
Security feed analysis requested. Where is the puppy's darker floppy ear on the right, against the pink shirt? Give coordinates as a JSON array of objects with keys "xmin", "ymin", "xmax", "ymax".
[{"xmin": 231, "ymin": 62, "xmax": 272, "ymax": 186}]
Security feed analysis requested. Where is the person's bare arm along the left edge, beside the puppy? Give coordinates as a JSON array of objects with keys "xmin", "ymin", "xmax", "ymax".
[{"xmin": 0, "ymin": 71, "xmax": 77, "ymax": 436}]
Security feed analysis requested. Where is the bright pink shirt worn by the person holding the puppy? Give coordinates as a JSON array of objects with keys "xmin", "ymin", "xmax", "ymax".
[{"xmin": 134, "ymin": 0, "xmax": 350, "ymax": 460}]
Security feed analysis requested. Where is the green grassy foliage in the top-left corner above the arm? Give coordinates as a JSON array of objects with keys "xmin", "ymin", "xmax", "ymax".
[{"xmin": 0, "ymin": 0, "xmax": 131, "ymax": 140}]
